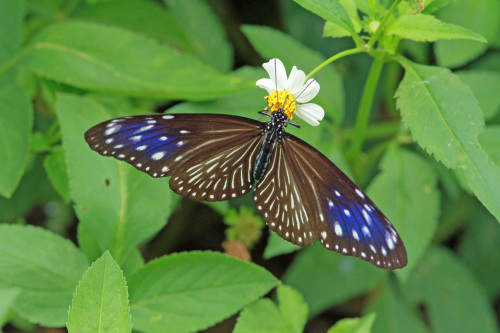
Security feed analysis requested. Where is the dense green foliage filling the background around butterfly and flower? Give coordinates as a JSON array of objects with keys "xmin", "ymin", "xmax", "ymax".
[{"xmin": 0, "ymin": 0, "xmax": 500, "ymax": 333}]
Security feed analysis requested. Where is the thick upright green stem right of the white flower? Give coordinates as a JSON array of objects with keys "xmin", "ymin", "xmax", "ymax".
[{"xmin": 348, "ymin": 58, "xmax": 384, "ymax": 161}]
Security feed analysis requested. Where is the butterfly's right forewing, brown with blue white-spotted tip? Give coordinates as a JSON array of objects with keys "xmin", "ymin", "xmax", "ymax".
[{"xmin": 282, "ymin": 134, "xmax": 407, "ymax": 269}]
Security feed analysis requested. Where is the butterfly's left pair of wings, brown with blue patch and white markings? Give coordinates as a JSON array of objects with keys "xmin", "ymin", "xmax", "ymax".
[{"xmin": 85, "ymin": 114, "xmax": 263, "ymax": 201}]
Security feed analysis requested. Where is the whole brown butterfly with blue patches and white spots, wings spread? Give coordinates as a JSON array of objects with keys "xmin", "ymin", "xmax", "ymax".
[{"xmin": 85, "ymin": 109, "xmax": 407, "ymax": 270}]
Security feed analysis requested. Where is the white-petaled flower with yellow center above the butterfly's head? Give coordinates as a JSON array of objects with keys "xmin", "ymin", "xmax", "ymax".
[{"xmin": 257, "ymin": 59, "xmax": 325, "ymax": 126}]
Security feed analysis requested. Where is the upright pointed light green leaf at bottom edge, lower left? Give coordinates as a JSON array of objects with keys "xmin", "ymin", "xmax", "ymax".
[{"xmin": 67, "ymin": 251, "xmax": 132, "ymax": 333}]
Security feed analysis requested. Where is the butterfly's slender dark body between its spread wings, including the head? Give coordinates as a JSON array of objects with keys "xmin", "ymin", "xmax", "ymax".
[{"xmin": 253, "ymin": 109, "xmax": 288, "ymax": 180}]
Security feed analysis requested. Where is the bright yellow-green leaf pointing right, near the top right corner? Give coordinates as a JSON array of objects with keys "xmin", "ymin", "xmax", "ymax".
[{"xmin": 387, "ymin": 14, "xmax": 487, "ymax": 43}]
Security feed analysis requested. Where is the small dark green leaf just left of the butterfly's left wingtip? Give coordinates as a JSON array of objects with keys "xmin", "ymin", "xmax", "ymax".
[{"xmin": 43, "ymin": 146, "xmax": 70, "ymax": 203}]
